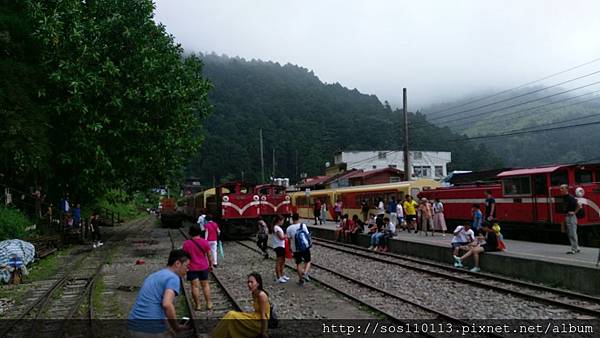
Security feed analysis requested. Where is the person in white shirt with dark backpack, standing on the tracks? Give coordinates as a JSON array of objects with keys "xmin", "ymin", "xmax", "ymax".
[{"xmin": 286, "ymin": 213, "xmax": 312, "ymax": 286}]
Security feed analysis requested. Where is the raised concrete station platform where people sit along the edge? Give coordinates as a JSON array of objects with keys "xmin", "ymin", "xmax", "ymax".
[{"xmin": 302, "ymin": 219, "xmax": 600, "ymax": 295}]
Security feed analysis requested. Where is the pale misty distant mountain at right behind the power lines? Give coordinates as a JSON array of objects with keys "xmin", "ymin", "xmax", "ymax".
[{"xmin": 423, "ymin": 86, "xmax": 600, "ymax": 166}]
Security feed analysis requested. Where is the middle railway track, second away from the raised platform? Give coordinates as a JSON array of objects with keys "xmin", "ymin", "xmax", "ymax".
[{"xmin": 237, "ymin": 241, "xmax": 492, "ymax": 337}]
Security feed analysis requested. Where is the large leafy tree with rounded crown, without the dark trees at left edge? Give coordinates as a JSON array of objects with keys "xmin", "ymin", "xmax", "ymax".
[{"xmin": 28, "ymin": 0, "xmax": 210, "ymax": 195}]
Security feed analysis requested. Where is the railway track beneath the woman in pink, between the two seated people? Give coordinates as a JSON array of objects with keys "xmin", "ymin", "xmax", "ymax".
[{"xmin": 169, "ymin": 228, "xmax": 242, "ymax": 337}]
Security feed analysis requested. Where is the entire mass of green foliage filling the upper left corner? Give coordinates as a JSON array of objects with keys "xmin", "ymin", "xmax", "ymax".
[{"xmin": 0, "ymin": 0, "xmax": 210, "ymax": 200}]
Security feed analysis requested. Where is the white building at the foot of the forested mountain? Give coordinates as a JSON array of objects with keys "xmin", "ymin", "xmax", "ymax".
[{"xmin": 334, "ymin": 150, "xmax": 452, "ymax": 179}]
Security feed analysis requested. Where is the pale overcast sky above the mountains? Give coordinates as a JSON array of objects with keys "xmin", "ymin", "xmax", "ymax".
[{"xmin": 155, "ymin": 0, "xmax": 600, "ymax": 110}]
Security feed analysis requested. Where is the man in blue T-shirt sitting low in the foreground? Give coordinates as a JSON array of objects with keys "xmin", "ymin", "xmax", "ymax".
[{"xmin": 127, "ymin": 249, "xmax": 190, "ymax": 338}]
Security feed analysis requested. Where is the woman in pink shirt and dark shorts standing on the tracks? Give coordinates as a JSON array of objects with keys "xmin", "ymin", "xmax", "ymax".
[{"xmin": 183, "ymin": 224, "xmax": 212, "ymax": 311}]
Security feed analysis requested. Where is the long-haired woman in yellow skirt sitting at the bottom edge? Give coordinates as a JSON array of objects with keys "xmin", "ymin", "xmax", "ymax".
[{"xmin": 211, "ymin": 272, "xmax": 271, "ymax": 338}]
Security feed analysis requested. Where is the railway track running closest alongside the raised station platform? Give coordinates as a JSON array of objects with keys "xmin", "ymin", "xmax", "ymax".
[{"xmin": 313, "ymin": 238, "xmax": 600, "ymax": 319}]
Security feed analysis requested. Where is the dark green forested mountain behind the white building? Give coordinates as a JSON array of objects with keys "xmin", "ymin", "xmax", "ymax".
[{"xmin": 188, "ymin": 54, "xmax": 502, "ymax": 185}]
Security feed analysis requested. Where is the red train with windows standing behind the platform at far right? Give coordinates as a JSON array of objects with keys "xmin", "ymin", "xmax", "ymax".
[{"xmin": 419, "ymin": 163, "xmax": 600, "ymax": 245}]
